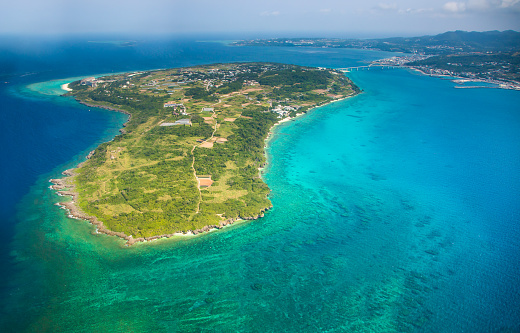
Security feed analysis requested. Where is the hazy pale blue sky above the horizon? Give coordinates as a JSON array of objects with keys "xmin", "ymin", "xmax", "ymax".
[{"xmin": 0, "ymin": 0, "xmax": 520, "ymax": 38}]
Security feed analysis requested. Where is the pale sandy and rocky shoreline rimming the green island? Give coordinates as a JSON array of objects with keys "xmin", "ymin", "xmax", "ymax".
[{"xmin": 49, "ymin": 78, "xmax": 360, "ymax": 246}]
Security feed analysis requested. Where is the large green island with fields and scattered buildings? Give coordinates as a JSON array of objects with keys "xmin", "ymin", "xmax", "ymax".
[{"xmin": 51, "ymin": 63, "xmax": 360, "ymax": 245}]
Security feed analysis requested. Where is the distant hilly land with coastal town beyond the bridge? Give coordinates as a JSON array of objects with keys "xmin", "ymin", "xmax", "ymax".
[{"xmin": 236, "ymin": 30, "xmax": 520, "ymax": 90}]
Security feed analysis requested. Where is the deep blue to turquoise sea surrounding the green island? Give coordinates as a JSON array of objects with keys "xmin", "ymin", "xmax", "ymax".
[{"xmin": 0, "ymin": 36, "xmax": 520, "ymax": 332}]
